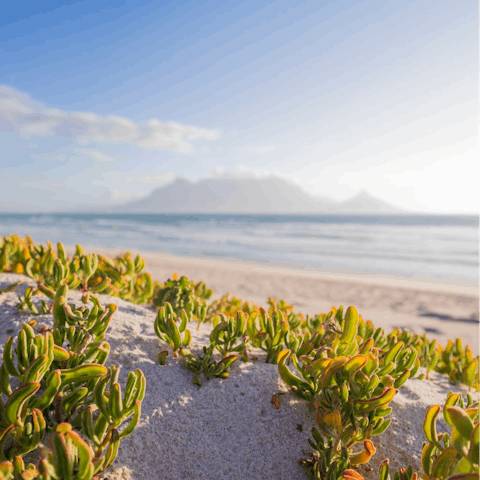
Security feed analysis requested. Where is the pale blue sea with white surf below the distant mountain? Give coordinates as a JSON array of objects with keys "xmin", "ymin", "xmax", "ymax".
[{"xmin": 0, "ymin": 213, "xmax": 479, "ymax": 281}]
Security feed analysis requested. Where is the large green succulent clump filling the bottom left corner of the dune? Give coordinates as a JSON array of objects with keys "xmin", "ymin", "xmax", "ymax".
[{"xmin": 0, "ymin": 312, "xmax": 145, "ymax": 479}]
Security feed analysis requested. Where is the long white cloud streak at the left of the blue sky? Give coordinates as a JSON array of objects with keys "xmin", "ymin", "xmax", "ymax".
[{"xmin": 0, "ymin": 86, "xmax": 217, "ymax": 153}]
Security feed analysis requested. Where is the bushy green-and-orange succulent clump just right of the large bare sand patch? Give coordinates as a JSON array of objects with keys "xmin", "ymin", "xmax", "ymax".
[{"xmin": 278, "ymin": 307, "xmax": 417, "ymax": 479}]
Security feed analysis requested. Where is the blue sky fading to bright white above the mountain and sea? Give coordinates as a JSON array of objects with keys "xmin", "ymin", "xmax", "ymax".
[{"xmin": 0, "ymin": 0, "xmax": 480, "ymax": 214}]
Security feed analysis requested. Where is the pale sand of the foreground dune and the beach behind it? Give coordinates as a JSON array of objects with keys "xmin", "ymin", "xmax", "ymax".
[{"xmin": 0, "ymin": 249, "xmax": 479, "ymax": 480}]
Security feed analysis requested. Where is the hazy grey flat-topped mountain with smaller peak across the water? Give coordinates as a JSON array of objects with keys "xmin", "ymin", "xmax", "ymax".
[{"xmin": 104, "ymin": 176, "xmax": 403, "ymax": 214}]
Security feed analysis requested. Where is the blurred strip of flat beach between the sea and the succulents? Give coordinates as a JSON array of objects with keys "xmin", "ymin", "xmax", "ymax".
[{"xmin": 67, "ymin": 246, "xmax": 480, "ymax": 355}]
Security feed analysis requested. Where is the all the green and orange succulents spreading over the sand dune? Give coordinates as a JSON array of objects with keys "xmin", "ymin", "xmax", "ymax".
[{"xmin": 0, "ymin": 235, "xmax": 480, "ymax": 480}]
